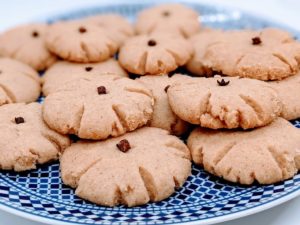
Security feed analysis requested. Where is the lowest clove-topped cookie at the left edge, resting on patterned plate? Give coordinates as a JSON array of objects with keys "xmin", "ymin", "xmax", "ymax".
[{"xmin": 0, "ymin": 102, "xmax": 70, "ymax": 171}]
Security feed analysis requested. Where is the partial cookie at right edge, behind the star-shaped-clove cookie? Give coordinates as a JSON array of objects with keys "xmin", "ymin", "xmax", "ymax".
[{"xmin": 269, "ymin": 73, "xmax": 300, "ymax": 120}]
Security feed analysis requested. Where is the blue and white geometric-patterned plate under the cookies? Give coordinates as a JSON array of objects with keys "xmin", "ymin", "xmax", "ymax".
[{"xmin": 0, "ymin": 3, "xmax": 300, "ymax": 224}]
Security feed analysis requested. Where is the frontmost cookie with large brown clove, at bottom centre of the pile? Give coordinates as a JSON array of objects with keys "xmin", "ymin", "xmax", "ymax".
[{"xmin": 60, "ymin": 127, "xmax": 191, "ymax": 207}]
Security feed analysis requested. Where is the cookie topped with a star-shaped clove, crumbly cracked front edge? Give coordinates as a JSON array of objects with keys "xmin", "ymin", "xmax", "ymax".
[{"xmin": 168, "ymin": 77, "xmax": 281, "ymax": 129}]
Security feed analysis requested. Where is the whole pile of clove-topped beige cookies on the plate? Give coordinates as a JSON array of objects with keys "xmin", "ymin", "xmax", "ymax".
[{"xmin": 0, "ymin": 4, "xmax": 300, "ymax": 206}]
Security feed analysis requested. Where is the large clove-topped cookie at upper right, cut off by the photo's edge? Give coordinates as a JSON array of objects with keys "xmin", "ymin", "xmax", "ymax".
[{"xmin": 197, "ymin": 28, "xmax": 300, "ymax": 80}]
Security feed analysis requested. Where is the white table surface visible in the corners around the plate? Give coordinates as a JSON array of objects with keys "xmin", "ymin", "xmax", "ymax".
[{"xmin": 0, "ymin": 0, "xmax": 300, "ymax": 225}]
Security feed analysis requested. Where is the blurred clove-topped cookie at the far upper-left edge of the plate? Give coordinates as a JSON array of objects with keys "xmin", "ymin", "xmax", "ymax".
[{"xmin": 0, "ymin": 24, "xmax": 56, "ymax": 71}]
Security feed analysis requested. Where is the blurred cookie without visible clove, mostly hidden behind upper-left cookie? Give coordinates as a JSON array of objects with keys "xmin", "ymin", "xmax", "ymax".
[{"xmin": 85, "ymin": 13, "xmax": 134, "ymax": 44}]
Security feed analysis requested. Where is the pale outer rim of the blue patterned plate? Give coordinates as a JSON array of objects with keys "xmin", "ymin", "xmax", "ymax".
[{"xmin": 0, "ymin": 0, "xmax": 300, "ymax": 225}]
